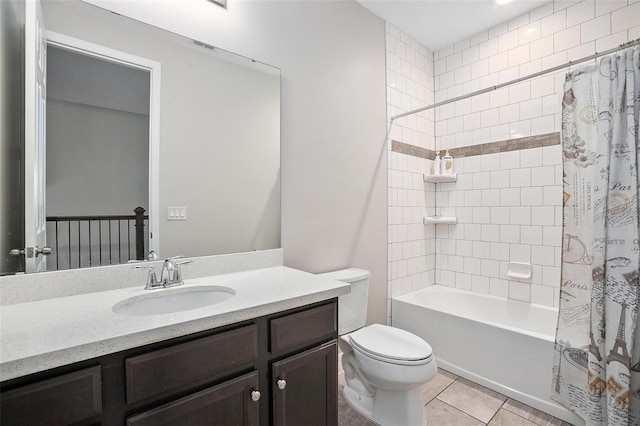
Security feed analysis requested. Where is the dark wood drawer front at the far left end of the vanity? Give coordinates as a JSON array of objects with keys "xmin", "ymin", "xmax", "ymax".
[{"xmin": 0, "ymin": 366, "xmax": 102, "ymax": 425}]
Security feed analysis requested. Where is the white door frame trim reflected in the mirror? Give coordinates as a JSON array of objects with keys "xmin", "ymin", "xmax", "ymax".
[{"xmin": 45, "ymin": 30, "xmax": 161, "ymax": 254}]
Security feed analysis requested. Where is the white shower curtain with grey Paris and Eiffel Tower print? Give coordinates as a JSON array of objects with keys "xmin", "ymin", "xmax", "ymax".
[{"xmin": 552, "ymin": 48, "xmax": 640, "ymax": 426}]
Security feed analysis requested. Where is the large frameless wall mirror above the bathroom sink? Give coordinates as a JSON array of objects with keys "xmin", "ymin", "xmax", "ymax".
[{"xmin": 2, "ymin": 0, "xmax": 280, "ymax": 274}]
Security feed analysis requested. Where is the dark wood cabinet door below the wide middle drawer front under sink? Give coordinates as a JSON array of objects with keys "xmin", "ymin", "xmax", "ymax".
[{"xmin": 127, "ymin": 371, "xmax": 260, "ymax": 426}]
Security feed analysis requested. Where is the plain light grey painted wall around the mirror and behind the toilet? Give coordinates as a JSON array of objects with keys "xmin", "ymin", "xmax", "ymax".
[{"xmin": 82, "ymin": 0, "xmax": 387, "ymax": 323}]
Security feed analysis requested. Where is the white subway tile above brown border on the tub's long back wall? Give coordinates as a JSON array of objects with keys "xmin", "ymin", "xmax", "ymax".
[{"xmin": 434, "ymin": 0, "xmax": 640, "ymax": 149}]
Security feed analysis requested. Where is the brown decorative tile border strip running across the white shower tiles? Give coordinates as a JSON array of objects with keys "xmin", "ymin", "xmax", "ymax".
[{"xmin": 391, "ymin": 132, "xmax": 560, "ymax": 160}]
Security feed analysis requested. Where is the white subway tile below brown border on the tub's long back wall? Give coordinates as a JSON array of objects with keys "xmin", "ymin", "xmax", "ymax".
[{"xmin": 435, "ymin": 145, "xmax": 562, "ymax": 306}]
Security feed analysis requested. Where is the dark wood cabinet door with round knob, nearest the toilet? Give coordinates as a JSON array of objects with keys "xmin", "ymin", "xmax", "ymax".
[{"xmin": 272, "ymin": 340, "xmax": 338, "ymax": 426}]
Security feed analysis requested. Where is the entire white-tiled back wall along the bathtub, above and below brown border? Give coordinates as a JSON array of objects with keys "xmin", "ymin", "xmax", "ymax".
[{"xmin": 434, "ymin": 0, "xmax": 640, "ymax": 305}]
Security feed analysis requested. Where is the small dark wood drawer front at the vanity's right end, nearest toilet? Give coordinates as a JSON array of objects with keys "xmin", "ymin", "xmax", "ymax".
[{"xmin": 270, "ymin": 302, "xmax": 337, "ymax": 353}]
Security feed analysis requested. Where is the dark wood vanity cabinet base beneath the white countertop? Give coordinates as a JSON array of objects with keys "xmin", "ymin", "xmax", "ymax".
[{"xmin": 0, "ymin": 299, "xmax": 338, "ymax": 426}]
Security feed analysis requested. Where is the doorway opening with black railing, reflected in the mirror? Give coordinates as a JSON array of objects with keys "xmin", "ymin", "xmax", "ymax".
[{"xmin": 46, "ymin": 44, "xmax": 150, "ymax": 270}]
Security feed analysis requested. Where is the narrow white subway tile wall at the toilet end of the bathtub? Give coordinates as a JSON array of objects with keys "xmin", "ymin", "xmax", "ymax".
[{"xmin": 386, "ymin": 24, "xmax": 436, "ymax": 322}]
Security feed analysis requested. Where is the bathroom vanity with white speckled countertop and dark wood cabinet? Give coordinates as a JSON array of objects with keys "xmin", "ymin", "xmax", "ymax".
[{"xmin": 0, "ymin": 267, "xmax": 349, "ymax": 426}]
